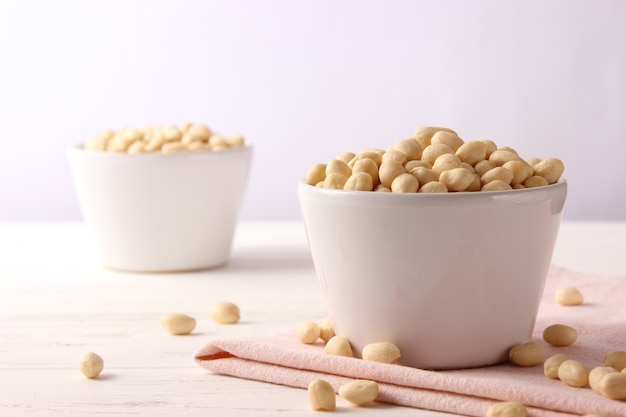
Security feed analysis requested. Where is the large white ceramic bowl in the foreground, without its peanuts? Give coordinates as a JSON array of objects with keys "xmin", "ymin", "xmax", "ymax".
[{"xmin": 298, "ymin": 181, "xmax": 567, "ymax": 369}]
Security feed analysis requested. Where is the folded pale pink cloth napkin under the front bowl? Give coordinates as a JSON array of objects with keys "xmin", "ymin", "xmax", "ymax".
[{"xmin": 195, "ymin": 267, "xmax": 626, "ymax": 417}]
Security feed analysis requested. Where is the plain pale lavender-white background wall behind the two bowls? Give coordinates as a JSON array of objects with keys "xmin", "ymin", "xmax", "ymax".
[{"xmin": 0, "ymin": 0, "xmax": 626, "ymax": 221}]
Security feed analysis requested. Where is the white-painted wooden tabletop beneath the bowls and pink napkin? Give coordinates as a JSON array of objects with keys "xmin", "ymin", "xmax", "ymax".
[{"xmin": 0, "ymin": 222, "xmax": 626, "ymax": 417}]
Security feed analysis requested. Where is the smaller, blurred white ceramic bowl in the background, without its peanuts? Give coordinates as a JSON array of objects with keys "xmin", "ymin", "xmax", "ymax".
[{"xmin": 67, "ymin": 145, "xmax": 252, "ymax": 272}]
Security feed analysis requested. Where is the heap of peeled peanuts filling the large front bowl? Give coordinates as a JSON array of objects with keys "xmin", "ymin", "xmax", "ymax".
[{"xmin": 306, "ymin": 126, "xmax": 565, "ymax": 193}]
